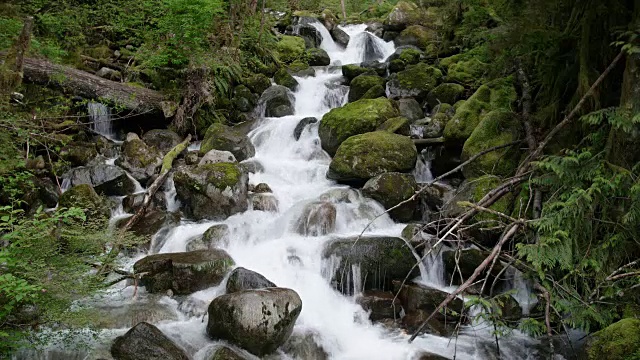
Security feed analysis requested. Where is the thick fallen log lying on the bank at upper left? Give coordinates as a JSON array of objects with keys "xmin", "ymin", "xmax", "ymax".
[{"xmin": 0, "ymin": 52, "xmax": 175, "ymax": 118}]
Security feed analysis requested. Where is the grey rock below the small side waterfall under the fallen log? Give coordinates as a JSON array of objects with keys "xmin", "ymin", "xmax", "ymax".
[{"xmin": 64, "ymin": 164, "xmax": 136, "ymax": 196}]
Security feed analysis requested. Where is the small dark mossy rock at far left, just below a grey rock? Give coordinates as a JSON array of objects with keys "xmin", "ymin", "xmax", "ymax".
[{"xmin": 58, "ymin": 184, "xmax": 111, "ymax": 221}]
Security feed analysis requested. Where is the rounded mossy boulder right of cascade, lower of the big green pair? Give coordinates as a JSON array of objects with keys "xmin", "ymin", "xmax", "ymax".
[{"xmin": 327, "ymin": 131, "xmax": 418, "ymax": 183}]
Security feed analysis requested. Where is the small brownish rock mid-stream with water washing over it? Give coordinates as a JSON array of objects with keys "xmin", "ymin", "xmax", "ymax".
[{"xmin": 295, "ymin": 201, "xmax": 336, "ymax": 236}]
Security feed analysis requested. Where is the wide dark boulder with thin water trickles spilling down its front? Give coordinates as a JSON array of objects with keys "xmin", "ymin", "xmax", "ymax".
[{"xmin": 323, "ymin": 236, "xmax": 419, "ymax": 294}]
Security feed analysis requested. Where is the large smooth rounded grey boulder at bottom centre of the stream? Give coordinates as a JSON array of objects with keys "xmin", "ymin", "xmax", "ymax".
[{"xmin": 207, "ymin": 288, "xmax": 302, "ymax": 356}]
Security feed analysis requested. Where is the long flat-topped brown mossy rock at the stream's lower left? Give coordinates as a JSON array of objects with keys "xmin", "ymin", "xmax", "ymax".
[{"xmin": 133, "ymin": 249, "xmax": 235, "ymax": 295}]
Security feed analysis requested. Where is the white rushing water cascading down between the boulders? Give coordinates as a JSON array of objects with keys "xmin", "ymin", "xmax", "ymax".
[{"xmin": 19, "ymin": 24, "xmax": 534, "ymax": 360}]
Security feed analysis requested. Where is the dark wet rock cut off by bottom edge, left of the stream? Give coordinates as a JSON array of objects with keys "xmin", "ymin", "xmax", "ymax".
[{"xmin": 111, "ymin": 322, "xmax": 189, "ymax": 360}]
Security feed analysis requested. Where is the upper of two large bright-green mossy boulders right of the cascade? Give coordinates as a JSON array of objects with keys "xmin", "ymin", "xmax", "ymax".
[{"xmin": 318, "ymin": 98, "xmax": 399, "ymax": 155}]
